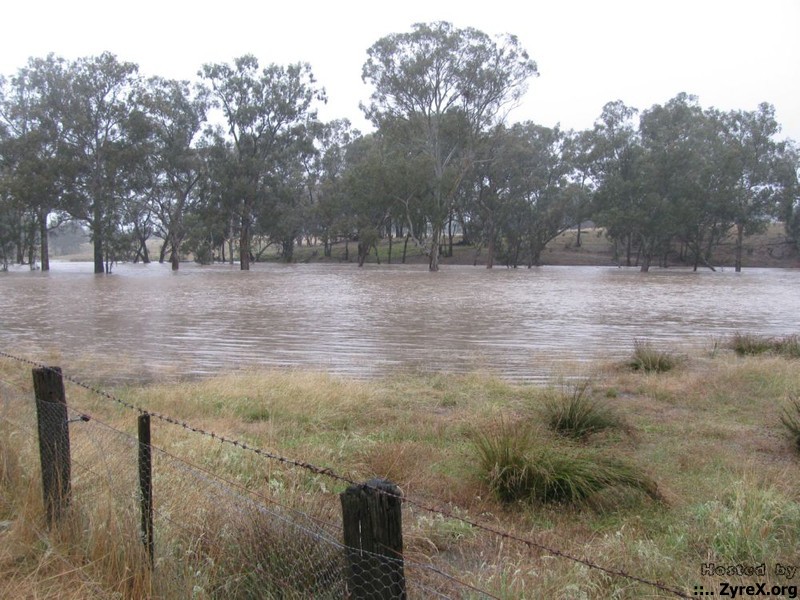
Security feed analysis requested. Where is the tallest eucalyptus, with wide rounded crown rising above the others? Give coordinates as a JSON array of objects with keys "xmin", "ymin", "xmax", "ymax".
[{"xmin": 362, "ymin": 22, "xmax": 537, "ymax": 271}]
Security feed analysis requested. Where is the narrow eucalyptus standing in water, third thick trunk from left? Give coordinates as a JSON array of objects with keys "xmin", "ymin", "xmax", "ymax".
[{"xmin": 141, "ymin": 77, "xmax": 207, "ymax": 271}]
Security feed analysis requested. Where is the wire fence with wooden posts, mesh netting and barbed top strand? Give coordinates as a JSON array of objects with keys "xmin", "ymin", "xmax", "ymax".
[{"xmin": 0, "ymin": 352, "xmax": 691, "ymax": 599}]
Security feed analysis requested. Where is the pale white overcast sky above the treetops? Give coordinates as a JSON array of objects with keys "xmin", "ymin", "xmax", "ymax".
[{"xmin": 0, "ymin": 0, "xmax": 800, "ymax": 141}]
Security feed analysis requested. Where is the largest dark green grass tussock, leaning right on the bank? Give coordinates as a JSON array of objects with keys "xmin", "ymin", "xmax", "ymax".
[{"xmin": 474, "ymin": 424, "xmax": 661, "ymax": 507}]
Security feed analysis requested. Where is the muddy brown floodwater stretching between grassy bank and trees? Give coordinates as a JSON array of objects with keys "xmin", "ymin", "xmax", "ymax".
[{"xmin": 0, "ymin": 262, "xmax": 800, "ymax": 381}]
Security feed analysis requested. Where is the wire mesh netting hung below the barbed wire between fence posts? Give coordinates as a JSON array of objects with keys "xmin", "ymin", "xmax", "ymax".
[{"xmin": 0, "ymin": 358, "xmax": 512, "ymax": 598}]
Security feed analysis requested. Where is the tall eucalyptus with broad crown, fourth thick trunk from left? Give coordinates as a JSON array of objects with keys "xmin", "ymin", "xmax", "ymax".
[{"xmin": 199, "ymin": 54, "xmax": 325, "ymax": 270}]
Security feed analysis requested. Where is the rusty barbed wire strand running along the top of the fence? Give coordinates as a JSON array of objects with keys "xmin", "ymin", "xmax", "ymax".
[{"xmin": 0, "ymin": 351, "xmax": 693, "ymax": 599}]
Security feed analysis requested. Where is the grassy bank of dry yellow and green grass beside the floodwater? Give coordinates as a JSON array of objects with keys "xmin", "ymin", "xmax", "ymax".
[{"xmin": 0, "ymin": 348, "xmax": 800, "ymax": 598}]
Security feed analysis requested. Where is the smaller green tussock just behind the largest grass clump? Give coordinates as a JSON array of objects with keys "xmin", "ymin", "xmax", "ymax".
[{"xmin": 545, "ymin": 382, "xmax": 622, "ymax": 439}]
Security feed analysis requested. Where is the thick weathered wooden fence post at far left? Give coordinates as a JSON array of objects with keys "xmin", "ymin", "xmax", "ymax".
[{"xmin": 33, "ymin": 367, "xmax": 71, "ymax": 526}]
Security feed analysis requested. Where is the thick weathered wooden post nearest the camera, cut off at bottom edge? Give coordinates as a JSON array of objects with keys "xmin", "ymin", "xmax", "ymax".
[{"xmin": 340, "ymin": 479, "xmax": 406, "ymax": 600}]
